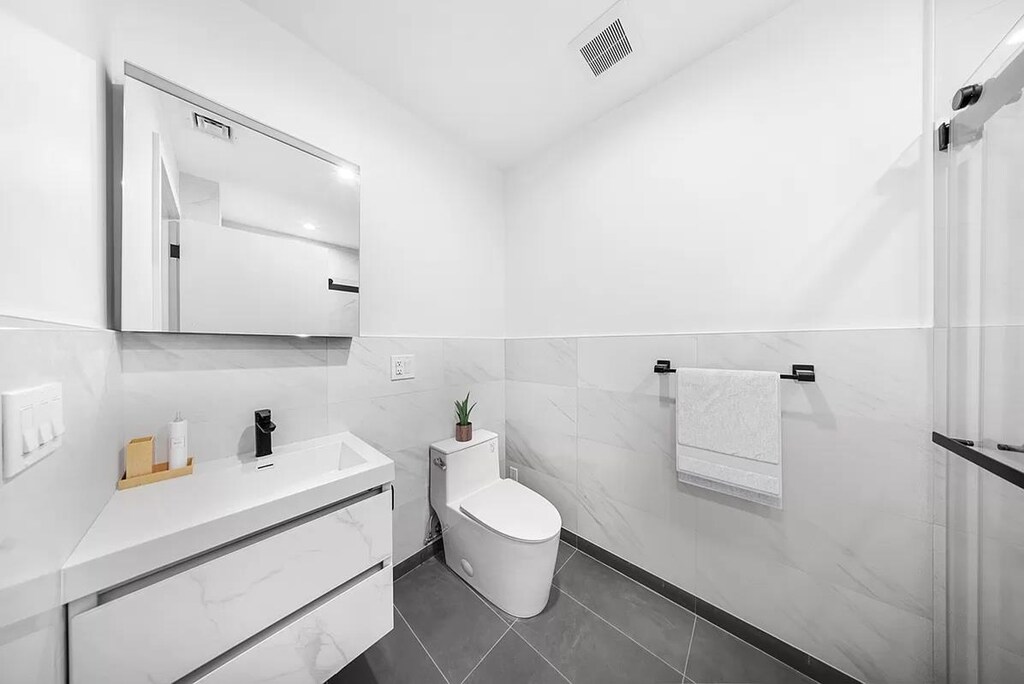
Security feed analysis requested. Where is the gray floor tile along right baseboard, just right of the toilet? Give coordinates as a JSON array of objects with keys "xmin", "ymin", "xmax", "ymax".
[{"xmin": 555, "ymin": 553, "xmax": 696, "ymax": 672}]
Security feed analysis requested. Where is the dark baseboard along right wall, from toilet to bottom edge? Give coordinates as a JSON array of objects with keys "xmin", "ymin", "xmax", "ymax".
[{"xmin": 561, "ymin": 528, "xmax": 861, "ymax": 684}]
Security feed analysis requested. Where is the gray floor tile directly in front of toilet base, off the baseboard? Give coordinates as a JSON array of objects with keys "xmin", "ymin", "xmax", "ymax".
[{"xmin": 512, "ymin": 587, "xmax": 683, "ymax": 684}]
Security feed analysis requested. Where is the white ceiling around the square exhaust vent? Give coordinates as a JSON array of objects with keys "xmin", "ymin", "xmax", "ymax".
[{"xmin": 245, "ymin": 0, "xmax": 793, "ymax": 167}]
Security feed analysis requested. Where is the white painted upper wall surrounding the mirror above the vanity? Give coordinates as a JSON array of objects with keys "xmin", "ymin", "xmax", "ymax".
[{"xmin": 100, "ymin": 0, "xmax": 504, "ymax": 337}]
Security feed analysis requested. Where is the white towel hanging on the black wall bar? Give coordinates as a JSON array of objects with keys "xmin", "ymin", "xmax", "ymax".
[{"xmin": 676, "ymin": 369, "xmax": 782, "ymax": 507}]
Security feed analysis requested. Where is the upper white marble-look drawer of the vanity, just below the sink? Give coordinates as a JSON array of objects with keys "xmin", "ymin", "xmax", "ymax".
[{"xmin": 69, "ymin": 493, "xmax": 391, "ymax": 684}]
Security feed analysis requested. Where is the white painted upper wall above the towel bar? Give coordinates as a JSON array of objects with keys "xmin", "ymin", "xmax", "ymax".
[{"xmin": 506, "ymin": 0, "xmax": 932, "ymax": 337}]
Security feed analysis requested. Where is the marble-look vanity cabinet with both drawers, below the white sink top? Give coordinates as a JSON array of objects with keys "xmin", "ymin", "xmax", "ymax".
[{"xmin": 69, "ymin": 488, "xmax": 393, "ymax": 684}]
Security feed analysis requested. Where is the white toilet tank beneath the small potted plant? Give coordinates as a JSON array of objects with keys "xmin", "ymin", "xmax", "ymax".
[{"xmin": 430, "ymin": 430, "xmax": 501, "ymax": 510}]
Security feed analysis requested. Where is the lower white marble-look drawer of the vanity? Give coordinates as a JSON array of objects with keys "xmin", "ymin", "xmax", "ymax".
[{"xmin": 196, "ymin": 567, "xmax": 394, "ymax": 684}]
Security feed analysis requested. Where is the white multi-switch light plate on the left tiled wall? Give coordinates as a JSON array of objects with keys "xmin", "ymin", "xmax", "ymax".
[{"xmin": 0, "ymin": 383, "xmax": 65, "ymax": 479}]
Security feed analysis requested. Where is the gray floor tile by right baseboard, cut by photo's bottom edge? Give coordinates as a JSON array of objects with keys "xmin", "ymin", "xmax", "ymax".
[{"xmin": 686, "ymin": 619, "xmax": 813, "ymax": 684}]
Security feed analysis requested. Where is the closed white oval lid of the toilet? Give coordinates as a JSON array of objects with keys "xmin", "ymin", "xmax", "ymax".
[{"xmin": 459, "ymin": 480, "xmax": 562, "ymax": 542}]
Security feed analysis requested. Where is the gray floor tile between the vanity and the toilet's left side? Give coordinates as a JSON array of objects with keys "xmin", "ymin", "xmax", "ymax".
[{"xmin": 394, "ymin": 558, "xmax": 508, "ymax": 682}]
